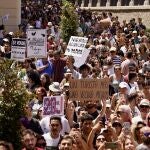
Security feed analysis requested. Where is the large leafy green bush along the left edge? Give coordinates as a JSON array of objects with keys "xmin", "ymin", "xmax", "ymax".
[{"xmin": 0, "ymin": 58, "xmax": 28, "ymax": 150}]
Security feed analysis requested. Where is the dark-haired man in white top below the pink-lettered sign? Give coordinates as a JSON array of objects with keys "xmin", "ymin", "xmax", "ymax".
[{"xmin": 43, "ymin": 116, "xmax": 62, "ymax": 150}]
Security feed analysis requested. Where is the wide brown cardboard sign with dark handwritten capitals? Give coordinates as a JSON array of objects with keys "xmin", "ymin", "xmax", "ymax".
[{"xmin": 69, "ymin": 79, "xmax": 109, "ymax": 102}]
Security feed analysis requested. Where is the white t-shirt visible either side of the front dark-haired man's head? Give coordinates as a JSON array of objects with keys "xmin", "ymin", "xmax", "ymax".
[{"xmin": 40, "ymin": 116, "xmax": 70, "ymax": 135}]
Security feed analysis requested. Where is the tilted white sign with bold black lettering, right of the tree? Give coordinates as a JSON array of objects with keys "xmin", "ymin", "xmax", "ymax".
[{"xmin": 65, "ymin": 36, "xmax": 88, "ymax": 57}]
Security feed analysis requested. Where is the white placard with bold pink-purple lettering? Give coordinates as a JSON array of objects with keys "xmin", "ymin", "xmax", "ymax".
[{"xmin": 43, "ymin": 96, "xmax": 64, "ymax": 116}]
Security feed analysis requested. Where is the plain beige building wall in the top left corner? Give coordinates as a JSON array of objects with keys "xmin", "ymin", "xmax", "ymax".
[{"xmin": 0, "ymin": 0, "xmax": 21, "ymax": 32}]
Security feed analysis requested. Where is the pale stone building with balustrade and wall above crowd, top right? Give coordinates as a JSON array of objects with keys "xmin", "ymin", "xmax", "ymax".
[{"xmin": 75, "ymin": 0, "xmax": 150, "ymax": 26}]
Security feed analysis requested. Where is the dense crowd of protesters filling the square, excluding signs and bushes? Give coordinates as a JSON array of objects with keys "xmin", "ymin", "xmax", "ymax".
[{"xmin": 0, "ymin": 0, "xmax": 150, "ymax": 150}]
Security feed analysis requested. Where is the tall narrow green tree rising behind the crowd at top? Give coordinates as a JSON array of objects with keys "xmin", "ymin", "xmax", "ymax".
[{"xmin": 60, "ymin": 0, "xmax": 79, "ymax": 43}]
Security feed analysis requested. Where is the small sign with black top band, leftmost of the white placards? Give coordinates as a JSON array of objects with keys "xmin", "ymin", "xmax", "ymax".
[{"xmin": 11, "ymin": 38, "xmax": 26, "ymax": 61}]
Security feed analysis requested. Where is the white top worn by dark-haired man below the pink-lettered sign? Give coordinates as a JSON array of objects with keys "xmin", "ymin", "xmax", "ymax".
[{"xmin": 43, "ymin": 133, "xmax": 60, "ymax": 147}]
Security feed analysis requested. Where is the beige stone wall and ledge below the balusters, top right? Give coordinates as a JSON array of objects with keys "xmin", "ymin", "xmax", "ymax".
[{"xmin": 81, "ymin": 5, "xmax": 150, "ymax": 28}]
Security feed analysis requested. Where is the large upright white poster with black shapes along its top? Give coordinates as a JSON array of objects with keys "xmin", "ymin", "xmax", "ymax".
[{"xmin": 27, "ymin": 29, "xmax": 47, "ymax": 58}]
